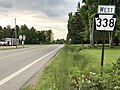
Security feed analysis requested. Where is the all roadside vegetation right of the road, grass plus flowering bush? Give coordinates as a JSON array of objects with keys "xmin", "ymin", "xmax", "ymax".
[{"xmin": 23, "ymin": 45, "xmax": 120, "ymax": 90}]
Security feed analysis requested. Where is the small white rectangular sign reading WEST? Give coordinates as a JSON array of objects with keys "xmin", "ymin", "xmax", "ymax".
[{"xmin": 98, "ymin": 5, "xmax": 115, "ymax": 14}]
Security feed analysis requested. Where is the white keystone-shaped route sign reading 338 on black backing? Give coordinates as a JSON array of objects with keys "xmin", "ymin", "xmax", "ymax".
[{"xmin": 95, "ymin": 14, "xmax": 116, "ymax": 31}]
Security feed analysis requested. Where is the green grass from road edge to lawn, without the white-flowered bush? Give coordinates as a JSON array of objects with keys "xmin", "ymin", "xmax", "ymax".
[{"xmin": 23, "ymin": 45, "xmax": 120, "ymax": 90}]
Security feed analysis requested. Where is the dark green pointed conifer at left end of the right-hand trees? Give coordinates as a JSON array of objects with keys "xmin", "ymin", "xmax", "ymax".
[{"xmin": 67, "ymin": 3, "xmax": 83, "ymax": 44}]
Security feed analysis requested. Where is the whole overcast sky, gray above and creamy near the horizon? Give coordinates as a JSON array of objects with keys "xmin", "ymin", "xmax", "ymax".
[{"xmin": 0, "ymin": 0, "xmax": 82, "ymax": 39}]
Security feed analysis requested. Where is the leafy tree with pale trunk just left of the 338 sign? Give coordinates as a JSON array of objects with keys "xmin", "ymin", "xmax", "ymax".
[{"xmin": 81, "ymin": 0, "xmax": 99, "ymax": 47}]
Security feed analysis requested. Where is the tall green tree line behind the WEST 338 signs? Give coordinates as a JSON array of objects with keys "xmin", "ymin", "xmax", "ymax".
[{"xmin": 67, "ymin": 0, "xmax": 120, "ymax": 47}]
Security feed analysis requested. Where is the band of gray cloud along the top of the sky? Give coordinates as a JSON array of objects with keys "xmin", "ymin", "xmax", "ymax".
[{"xmin": 0, "ymin": 0, "xmax": 77, "ymax": 17}]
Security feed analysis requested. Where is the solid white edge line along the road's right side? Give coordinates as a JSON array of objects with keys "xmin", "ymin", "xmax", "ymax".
[{"xmin": 0, "ymin": 46, "xmax": 63, "ymax": 86}]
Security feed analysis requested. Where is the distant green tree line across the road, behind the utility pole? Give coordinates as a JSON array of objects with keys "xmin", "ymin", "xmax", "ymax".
[{"xmin": 0, "ymin": 24, "xmax": 53, "ymax": 44}]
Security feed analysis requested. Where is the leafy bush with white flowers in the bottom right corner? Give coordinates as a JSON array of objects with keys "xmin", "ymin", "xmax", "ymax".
[{"xmin": 80, "ymin": 59, "xmax": 120, "ymax": 90}]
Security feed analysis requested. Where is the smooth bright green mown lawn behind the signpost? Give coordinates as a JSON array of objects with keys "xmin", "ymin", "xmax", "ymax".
[{"xmin": 81, "ymin": 46, "xmax": 120, "ymax": 66}]
